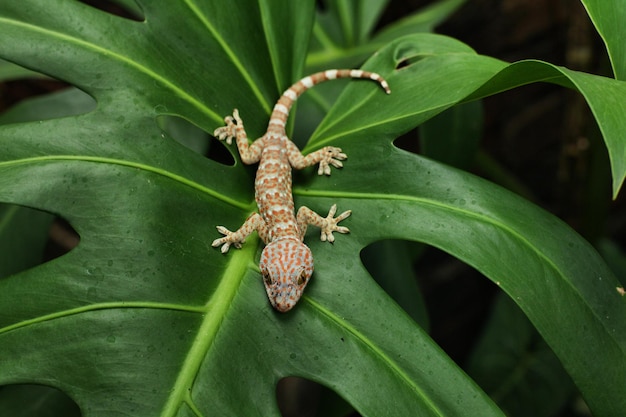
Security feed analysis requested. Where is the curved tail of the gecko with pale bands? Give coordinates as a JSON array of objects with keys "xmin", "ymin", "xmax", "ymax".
[{"xmin": 268, "ymin": 69, "xmax": 391, "ymax": 132}]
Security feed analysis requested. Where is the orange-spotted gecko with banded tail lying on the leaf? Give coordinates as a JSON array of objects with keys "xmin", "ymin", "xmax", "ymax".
[{"xmin": 212, "ymin": 69, "xmax": 391, "ymax": 312}]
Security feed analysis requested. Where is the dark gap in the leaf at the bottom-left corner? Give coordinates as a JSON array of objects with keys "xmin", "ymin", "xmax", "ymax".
[{"xmin": 0, "ymin": 384, "xmax": 82, "ymax": 417}]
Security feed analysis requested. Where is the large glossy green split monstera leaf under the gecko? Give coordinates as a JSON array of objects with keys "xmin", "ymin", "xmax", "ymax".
[{"xmin": 0, "ymin": 0, "xmax": 626, "ymax": 416}]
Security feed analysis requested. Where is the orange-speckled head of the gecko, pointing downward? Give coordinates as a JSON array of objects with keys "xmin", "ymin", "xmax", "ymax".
[{"xmin": 259, "ymin": 239, "xmax": 313, "ymax": 313}]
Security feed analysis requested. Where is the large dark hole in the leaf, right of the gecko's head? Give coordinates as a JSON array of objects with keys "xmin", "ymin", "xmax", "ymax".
[{"xmin": 361, "ymin": 240, "xmax": 499, "ymax": 364}]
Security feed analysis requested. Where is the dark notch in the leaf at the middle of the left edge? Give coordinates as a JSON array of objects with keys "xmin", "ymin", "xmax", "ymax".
[{"xmin": 0, "ymin": 204, "xmax": 80, "ymax": 277}]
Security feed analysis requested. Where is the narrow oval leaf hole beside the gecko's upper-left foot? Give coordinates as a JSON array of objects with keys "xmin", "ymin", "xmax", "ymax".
[{"xmin": 157, "ymin": 115, "xmax": 235, "ymax": 165}]
